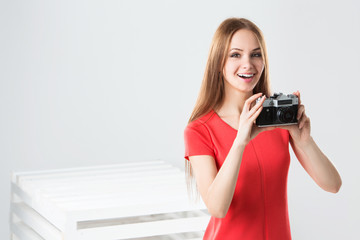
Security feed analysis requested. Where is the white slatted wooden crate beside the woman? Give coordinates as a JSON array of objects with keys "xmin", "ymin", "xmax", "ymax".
[{"xmin": 10, "ymin": 161, "xmax": 209, "ymax": 240}]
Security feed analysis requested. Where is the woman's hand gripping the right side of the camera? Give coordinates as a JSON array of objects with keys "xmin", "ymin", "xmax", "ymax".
[{"xmin": 281, "ymin": 91, "xmax": 311, "ymax": 144}]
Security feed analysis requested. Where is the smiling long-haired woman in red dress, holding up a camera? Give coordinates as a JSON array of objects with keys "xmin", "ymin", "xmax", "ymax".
[{"xmin": 184, "ymin": 18, "xmax": 341, "ymax": 240}]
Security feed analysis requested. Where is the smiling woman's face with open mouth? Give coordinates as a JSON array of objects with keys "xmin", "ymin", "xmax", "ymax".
[{"xmin": 223, "ymin": 29, "xmax": 264, "ymax": 93}]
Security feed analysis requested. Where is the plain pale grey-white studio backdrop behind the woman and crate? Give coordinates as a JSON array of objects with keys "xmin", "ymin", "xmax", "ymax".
[{"xmin": 0, "ymin": 0, "xmax": 360, "ymax": 240}]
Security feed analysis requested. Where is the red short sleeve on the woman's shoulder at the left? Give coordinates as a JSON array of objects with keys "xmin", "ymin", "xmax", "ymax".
[{"xmin": 184, "ymin": 122, "xmax": 215, "ymax": 160}]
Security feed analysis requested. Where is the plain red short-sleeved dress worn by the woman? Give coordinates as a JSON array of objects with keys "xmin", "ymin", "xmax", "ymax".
[{"xmin": 184, "ymin": 111, "xmax": 291, "ymax": 240}]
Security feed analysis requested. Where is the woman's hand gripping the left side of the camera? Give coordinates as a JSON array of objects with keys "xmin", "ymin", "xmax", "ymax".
[{"xmin": 235, "ymin": 93, "xmax": 275, "ymax": 145}]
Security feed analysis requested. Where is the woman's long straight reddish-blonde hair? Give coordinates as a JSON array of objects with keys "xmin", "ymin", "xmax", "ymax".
[{"xmin": 185, "ymin": 18, "xmax": 271, "ymax": 201}]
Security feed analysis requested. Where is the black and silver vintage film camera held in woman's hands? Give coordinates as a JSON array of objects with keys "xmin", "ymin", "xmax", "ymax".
[{"xmin": 256, "ymin": 93, "xmax": 299, "ymax": 127}]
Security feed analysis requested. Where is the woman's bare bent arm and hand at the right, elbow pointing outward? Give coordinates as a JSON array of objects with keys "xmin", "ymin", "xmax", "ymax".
[{"xmin": 284, "ymin": 91, "xmax": 342, "ymax": 193}]
